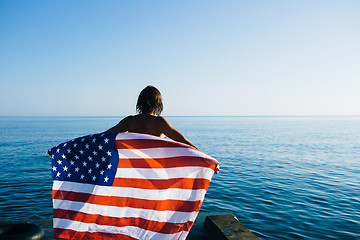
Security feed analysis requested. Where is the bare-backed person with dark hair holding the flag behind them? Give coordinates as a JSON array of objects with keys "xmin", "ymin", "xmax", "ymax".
[{"xmin": 106, "ymin": 85, "xmax": 197, "ymax": 149}]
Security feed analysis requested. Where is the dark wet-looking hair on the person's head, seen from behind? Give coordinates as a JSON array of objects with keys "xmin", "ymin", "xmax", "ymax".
[{"xmin": 136, "ymin": 85, "xmax": 163, "ymax": 116}]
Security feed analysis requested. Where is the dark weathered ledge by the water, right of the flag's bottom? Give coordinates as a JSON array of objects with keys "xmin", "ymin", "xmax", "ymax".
[{"xmin": 204, "ymin": 214, "xmax": 259, "ymax": 240}]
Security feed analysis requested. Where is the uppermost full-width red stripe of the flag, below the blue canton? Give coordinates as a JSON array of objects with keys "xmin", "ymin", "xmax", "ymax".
[{"xmin": 52, "ymin": 190, "xmax": 202, "ymax": 212}]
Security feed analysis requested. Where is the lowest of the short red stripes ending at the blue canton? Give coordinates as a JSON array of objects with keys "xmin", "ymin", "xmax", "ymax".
[{"xmin": 113, "ymin": 178, "xmax": 210, "ymax": 190}]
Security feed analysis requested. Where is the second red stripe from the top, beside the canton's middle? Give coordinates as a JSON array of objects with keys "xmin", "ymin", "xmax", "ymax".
[{"xmin": 118, "ymin": 156, "xmax": 216, "ymax": 170}]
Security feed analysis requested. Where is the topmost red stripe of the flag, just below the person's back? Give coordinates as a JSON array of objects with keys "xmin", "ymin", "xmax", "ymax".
[{"xmin": 116, "ymin": 139, "xmax": 197, "ymax": 150}]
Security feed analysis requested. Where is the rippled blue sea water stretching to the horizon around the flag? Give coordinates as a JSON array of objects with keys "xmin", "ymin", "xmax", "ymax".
[{"xmin": 0, "ymin": 117, "xmax": 360, "ymax": 240}]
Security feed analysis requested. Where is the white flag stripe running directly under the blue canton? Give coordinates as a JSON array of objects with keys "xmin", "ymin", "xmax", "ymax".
[{"xmin": 53, "ymin": 180, "xmax": 206, "ymax": 201}]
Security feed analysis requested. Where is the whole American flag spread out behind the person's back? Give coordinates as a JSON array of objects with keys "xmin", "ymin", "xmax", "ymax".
[{"xmin": 48, "ymin": 133, "xmax": 219, "ymax": 240}]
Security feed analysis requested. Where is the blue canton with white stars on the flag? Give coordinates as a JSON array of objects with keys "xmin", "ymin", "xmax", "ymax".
[{"xmin": 48, "ymin": 133, "xmax": 119, "ymax": 186}]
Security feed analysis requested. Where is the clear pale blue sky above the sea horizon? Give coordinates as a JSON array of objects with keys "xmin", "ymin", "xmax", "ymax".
[{"xmin": 0, "ymin": 0, "xmax": 360, "ymax": 116}]
